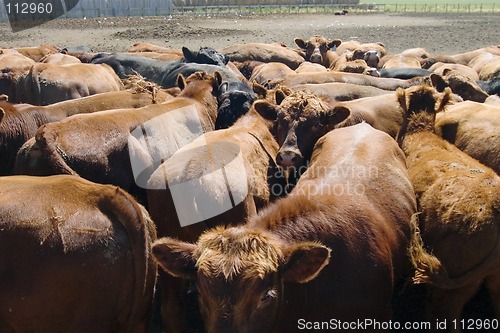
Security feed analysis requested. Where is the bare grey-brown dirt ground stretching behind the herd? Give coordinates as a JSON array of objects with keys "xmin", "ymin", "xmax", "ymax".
[{"xmin": 0, "ymin": 13, "xmax": 500, "ymax": 54}]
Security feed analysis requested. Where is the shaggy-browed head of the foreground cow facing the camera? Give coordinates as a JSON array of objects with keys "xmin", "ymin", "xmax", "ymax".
[{"xmin": 153, "ymin": 227, "xmax": 330, "ymax": 333}]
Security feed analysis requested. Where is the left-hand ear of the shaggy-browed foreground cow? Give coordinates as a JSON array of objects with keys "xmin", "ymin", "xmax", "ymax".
[{"xmin": 153, "ymin": 237, "xmax": 197, "ymax": 280}]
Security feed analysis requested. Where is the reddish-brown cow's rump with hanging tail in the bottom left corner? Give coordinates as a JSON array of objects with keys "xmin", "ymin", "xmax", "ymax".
[{"xmin": 0, "ymin": 175, "xmax": 156, "ymax": 333}]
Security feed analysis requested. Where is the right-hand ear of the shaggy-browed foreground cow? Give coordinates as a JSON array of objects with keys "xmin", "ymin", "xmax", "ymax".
[{"xmin": 282, "ymin": 243, "xmax": 331, "ymax": 283}]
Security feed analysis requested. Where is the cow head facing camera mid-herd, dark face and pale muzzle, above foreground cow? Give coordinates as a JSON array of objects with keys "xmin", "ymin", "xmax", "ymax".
[{"xmin": 254, "ymin": 90, "xmax": 350, "ymax": 170}]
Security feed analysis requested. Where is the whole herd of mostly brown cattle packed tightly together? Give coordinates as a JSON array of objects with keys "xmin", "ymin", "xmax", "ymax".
[{"xmin": 0, "ymin": 36, "xmax": 500, "ymax": 333}]
